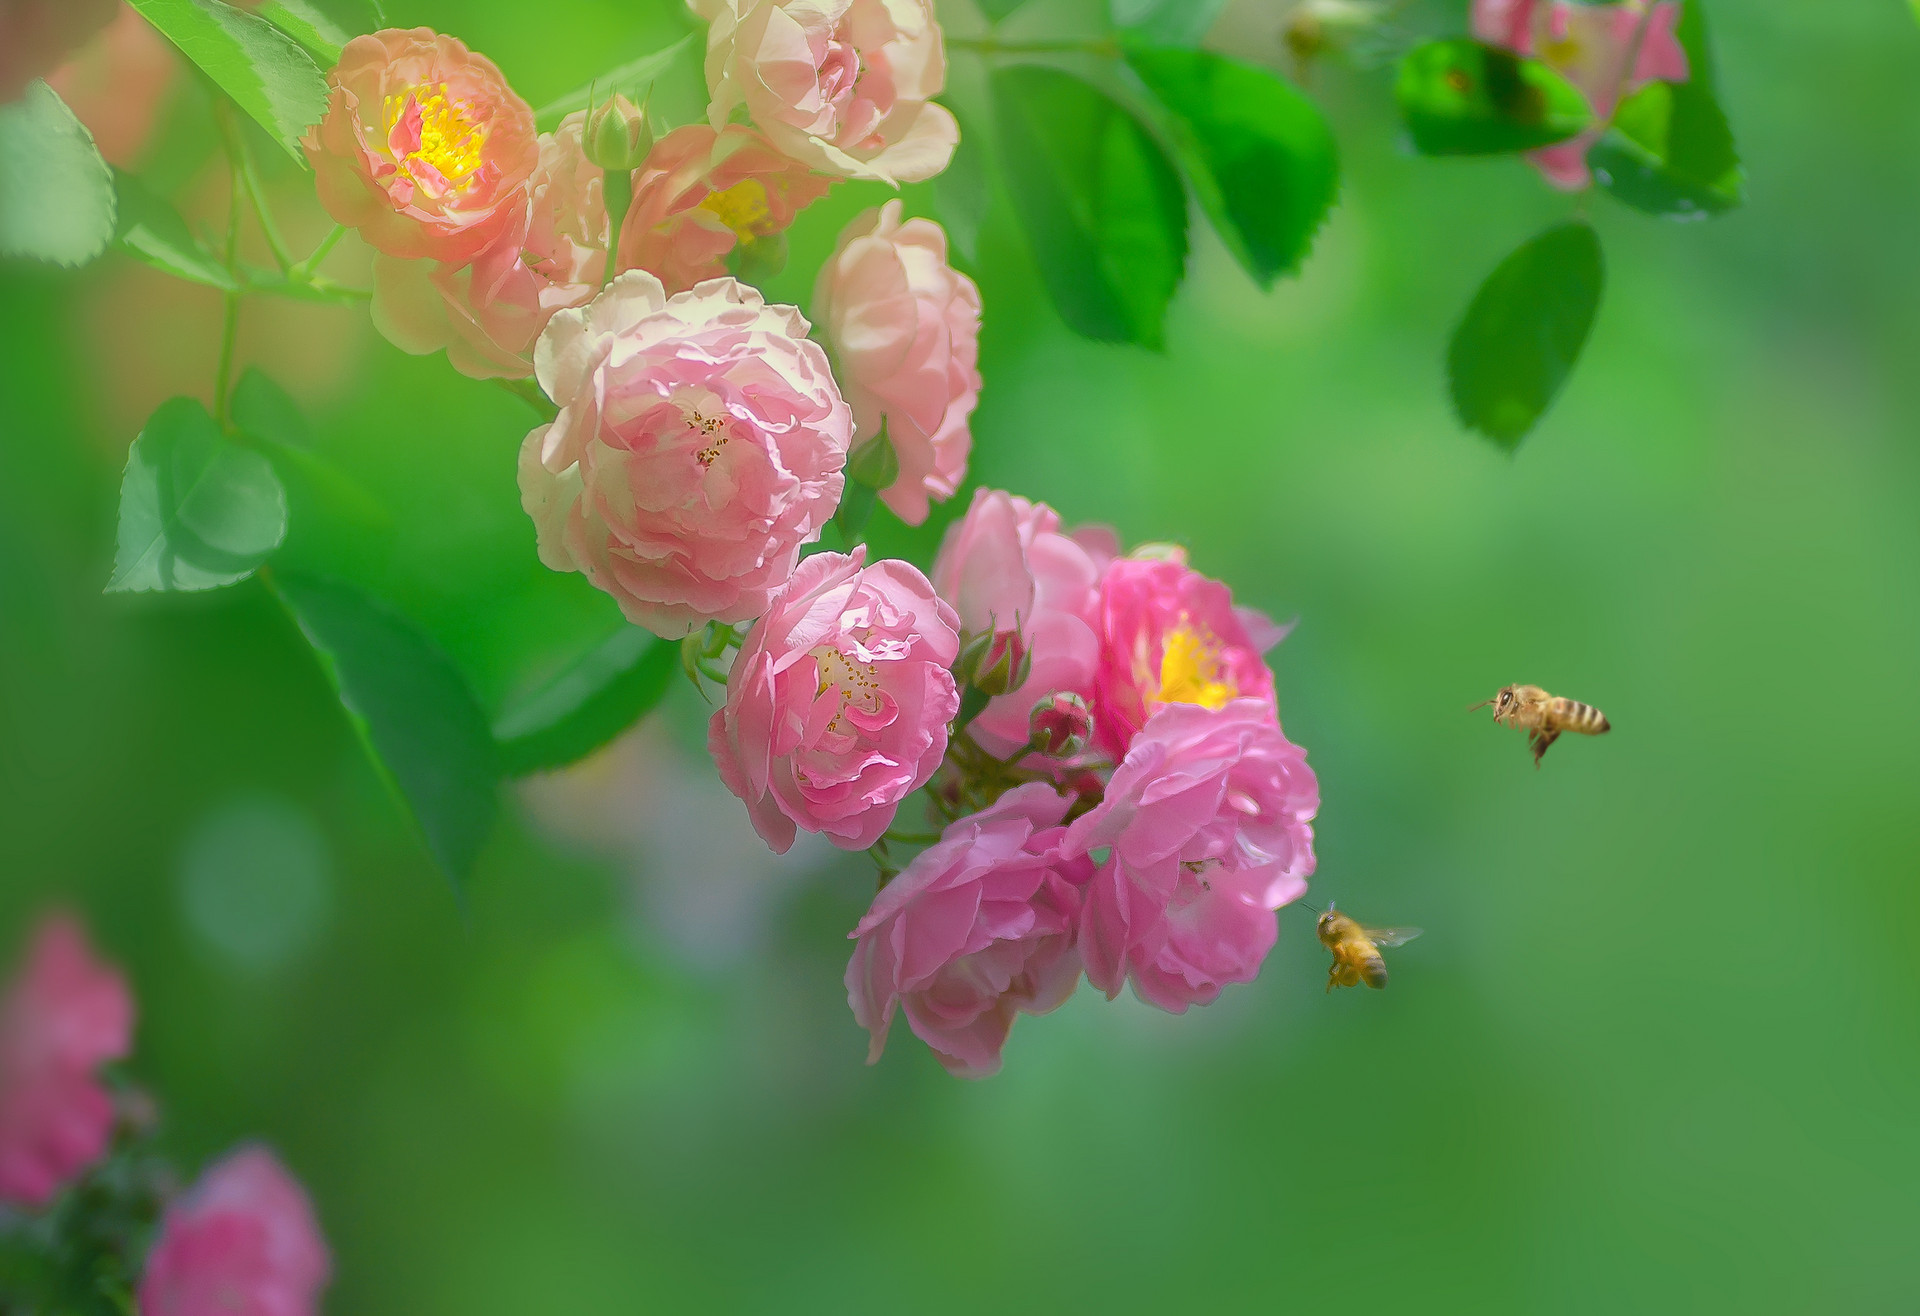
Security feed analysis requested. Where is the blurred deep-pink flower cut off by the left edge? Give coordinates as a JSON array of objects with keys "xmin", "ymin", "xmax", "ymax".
[{"xmin": 0, "ymin": 914, "xmax": 132, "ymax": 1206}]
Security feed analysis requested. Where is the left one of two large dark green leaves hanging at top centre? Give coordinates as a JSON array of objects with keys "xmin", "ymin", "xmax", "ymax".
[{"xmin": 993, "ymin": 63, "xmax": 1187, "ymax": 348}]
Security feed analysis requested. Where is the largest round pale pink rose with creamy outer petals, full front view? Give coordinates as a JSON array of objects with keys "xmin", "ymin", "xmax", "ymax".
[{"xmin": 520, "ymin": 269, "xmax": 852, "ymax": 640}]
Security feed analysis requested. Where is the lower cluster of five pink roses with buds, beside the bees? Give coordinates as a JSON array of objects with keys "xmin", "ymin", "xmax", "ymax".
[{"xmin": 708, "ymin": 490, "xmax": 1319, "ymax": 1076}]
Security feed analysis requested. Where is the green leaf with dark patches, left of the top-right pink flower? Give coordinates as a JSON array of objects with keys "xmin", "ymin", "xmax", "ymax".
[{"xmin": 1394, "ymin": 38, "xmax": 1594, "ymax": 156}]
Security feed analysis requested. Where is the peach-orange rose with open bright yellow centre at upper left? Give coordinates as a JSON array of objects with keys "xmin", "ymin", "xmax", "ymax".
[{"xmin": 301, "ymin": 27, "xmax": 540, "ymax": 265}]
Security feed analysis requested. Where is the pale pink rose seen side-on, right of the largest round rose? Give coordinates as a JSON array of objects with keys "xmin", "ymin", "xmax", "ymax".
[{"xmin": 814, "ymin": 202, "xmax": 979, "ymax": 526}]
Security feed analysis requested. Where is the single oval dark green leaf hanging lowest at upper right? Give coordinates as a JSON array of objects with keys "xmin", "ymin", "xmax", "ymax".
[{"xmin": 1448, "ymin": 219, "xmax": 1607, "ymax": 451}]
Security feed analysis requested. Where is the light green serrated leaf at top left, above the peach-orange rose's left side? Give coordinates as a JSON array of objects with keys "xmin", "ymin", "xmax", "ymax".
[{"xmin": 131, "ymin": 0, "xmax": 326, "ymax": 163}]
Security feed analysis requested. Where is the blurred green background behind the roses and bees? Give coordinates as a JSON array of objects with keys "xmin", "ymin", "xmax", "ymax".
[{"xmin": 0, "ymin": 0, "xmax": 1920, "ymax": 1316}]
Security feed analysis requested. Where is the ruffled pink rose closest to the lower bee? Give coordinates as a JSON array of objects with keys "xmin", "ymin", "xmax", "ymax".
[{"xmin": 1066, "ymin": 699, "xmax": 1319, "ymax": 1014}]
